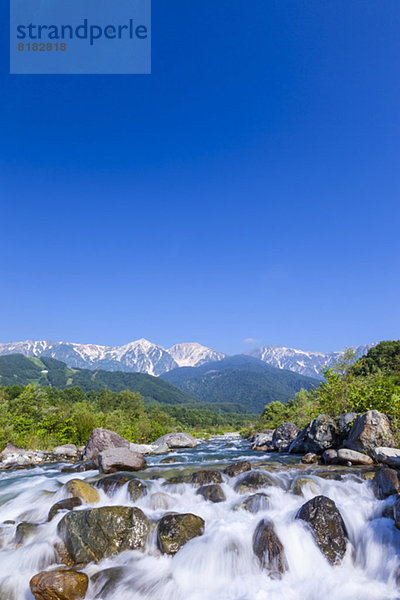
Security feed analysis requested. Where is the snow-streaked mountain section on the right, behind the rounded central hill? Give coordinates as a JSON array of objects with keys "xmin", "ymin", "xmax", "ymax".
[{"xmin": 246, "ymin": 344, "xmax": 374, "ymax": 379}]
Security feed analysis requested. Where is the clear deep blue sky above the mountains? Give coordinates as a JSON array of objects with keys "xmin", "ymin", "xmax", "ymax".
[{"xmin": 0, "ymin": 0, "xmax": 400, "ymax": 353}]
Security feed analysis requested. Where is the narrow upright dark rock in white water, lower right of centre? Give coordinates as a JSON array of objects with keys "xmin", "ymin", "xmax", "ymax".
[{"xmin": 253, "ymin": 519, "xmax": 287, "ymax": 578}]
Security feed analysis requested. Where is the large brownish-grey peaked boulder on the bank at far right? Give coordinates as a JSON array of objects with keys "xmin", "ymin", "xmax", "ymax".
[{"xmin": 343, "ymin": 410, "xmax": 396, "ymax": 456}]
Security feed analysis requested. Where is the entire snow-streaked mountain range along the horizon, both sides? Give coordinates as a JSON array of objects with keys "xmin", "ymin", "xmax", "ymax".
[{"xmin": 0, "ymin": 338, "xmax": 374, "ymax": 379}]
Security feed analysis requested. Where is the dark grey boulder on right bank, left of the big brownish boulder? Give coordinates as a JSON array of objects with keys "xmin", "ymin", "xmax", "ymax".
[{"xmin": 289, "ymin": 414, "xmax": 338, "ymax": 454}]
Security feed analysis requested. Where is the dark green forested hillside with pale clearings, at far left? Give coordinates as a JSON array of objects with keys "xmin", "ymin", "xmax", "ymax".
[{"xmin": 0, "ymin": 354, "xmax": 196, "ymax": 404}]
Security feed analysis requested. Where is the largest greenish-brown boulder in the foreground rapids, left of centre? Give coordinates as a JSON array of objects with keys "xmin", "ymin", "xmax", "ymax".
[{"xmin": 57, "ymin": 506, "xmax": 149, "ymax": 564}]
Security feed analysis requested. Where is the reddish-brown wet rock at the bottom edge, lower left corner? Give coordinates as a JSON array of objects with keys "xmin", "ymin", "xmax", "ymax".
[{"xmin": 29, "ymin": 569, "xmax": 89, "ymax": 600}]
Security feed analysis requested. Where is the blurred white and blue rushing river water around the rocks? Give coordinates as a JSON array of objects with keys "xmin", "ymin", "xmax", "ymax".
[{"xmin": 0, "ymin": 440, "xmax": 400, "ymax": 600}]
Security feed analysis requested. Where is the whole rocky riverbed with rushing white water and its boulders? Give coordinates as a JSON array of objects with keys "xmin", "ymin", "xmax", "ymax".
[{"xmin": 0, "ymin": 438, "xmax": 400, "ymax": 600}]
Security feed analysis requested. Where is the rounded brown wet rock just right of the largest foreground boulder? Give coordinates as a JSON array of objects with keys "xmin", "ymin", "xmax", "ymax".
[{"xmin": 157, "ymin": 513, "xmax": 205, "ymax": 554}]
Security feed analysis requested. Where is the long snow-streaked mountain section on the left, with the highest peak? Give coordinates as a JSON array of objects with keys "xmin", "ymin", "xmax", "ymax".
[{"xmin": 0, "ymin": 339, "xmax": 225, "ymax": 376}]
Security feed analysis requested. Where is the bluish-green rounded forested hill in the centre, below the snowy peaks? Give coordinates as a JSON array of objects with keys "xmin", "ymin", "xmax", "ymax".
[{"xmin": 161, "ymin": 355, "xmax": 319, "ymax": 412}]
